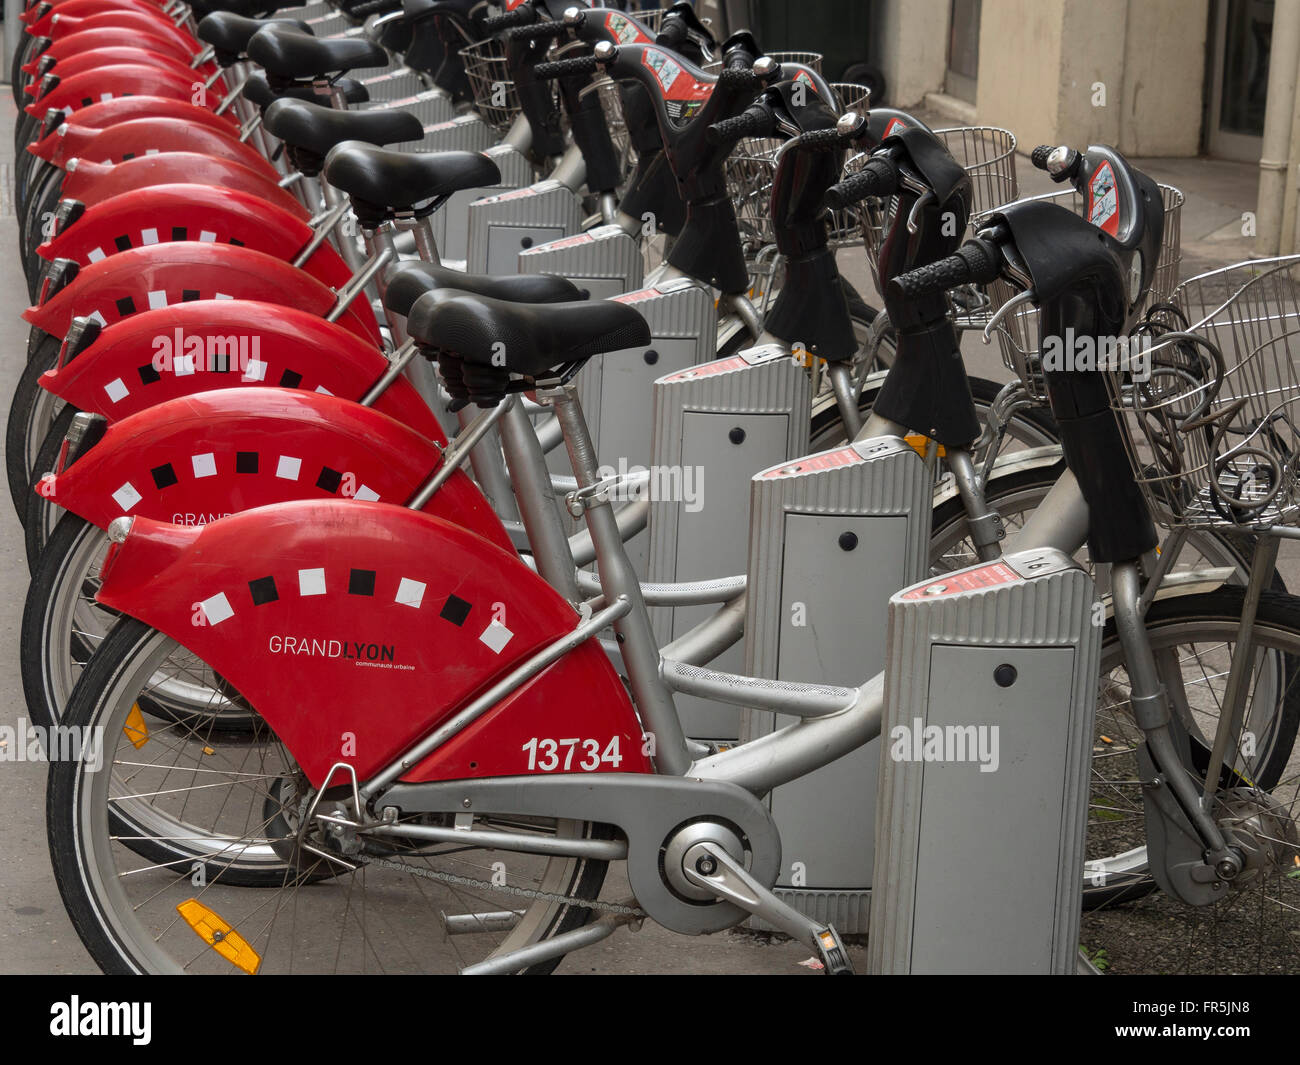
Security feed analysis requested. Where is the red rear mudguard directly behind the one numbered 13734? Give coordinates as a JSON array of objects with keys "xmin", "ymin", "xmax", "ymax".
[{"xmin": 36, "ymin": 388, "xmax": 514, "ymax": 553}]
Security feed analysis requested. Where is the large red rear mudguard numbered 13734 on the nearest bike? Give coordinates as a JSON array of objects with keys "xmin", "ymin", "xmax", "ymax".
[{"xmin": 98, "ymin": 501, "xmax": 650, "ymax": 787}]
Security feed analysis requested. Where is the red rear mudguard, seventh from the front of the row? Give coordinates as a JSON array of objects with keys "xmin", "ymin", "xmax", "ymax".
[{"xmin": 33, "ymin": 113, "xmax": 253, "ymax": 171}]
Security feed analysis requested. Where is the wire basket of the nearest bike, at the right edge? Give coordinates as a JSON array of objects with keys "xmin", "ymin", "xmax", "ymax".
[{"xmin": 1110, "ymin": 256, "xmax": 1300, "ymax": 528}]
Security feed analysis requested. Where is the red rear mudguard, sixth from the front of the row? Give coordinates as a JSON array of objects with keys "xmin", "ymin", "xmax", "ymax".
[{"xmin": 62, "ymin": 152, "xmax": 311, "ymax": 222}]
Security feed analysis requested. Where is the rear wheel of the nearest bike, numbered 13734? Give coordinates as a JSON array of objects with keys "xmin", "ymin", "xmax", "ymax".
[{"xmin": 46, "ymin": 619, "xmax": 608, "ymax": 974}]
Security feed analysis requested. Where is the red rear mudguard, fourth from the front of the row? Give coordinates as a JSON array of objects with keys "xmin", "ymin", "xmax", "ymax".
[{"xmin": 22, "ymin": 241, "xmax": 381, "ymax": 350}]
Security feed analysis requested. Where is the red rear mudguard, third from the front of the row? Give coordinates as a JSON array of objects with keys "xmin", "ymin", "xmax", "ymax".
[{"xmin": 40, "ymin": 299, "xmax": 446, "ymax": 443}]
